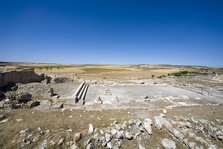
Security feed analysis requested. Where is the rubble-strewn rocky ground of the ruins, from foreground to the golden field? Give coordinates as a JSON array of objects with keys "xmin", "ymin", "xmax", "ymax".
[{"xmin": 0, "ymin": 75, "xmax": 223, "ymax": 149}]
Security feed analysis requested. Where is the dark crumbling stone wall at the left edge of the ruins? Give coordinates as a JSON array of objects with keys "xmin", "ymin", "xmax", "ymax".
[{"xmin": 0, "ymin": 68, "xmax": 44, "ymax": 88}]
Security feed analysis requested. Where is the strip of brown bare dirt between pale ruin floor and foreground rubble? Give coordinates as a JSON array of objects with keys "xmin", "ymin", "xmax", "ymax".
[{"xmin": 0, "ymin": 106, "xmax": 223, "ymax": 149}]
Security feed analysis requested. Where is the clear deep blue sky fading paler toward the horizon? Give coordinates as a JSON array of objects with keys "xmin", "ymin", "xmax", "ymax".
[{"xmin": 0, "ymin": 0, "xmax": 223, "ymax": 66}]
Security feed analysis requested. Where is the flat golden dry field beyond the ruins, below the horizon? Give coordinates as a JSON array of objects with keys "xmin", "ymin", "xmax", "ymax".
[{"xmin": 1, "ymin": 63, "xmax": 223, "ymax": 79}]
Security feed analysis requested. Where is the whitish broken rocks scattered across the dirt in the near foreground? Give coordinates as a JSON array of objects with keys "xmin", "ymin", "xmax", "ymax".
[{"xmin": 5, "ymin": 116, "xmax": 222, "ymax": 149}]
